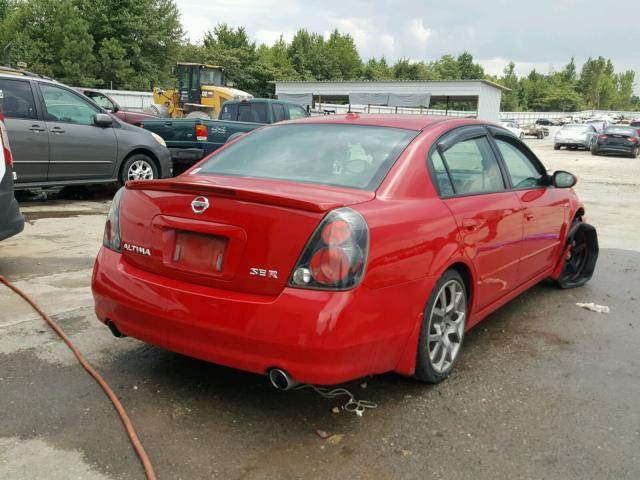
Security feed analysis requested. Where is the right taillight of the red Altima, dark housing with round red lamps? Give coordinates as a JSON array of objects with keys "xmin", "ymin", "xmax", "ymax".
[{"xmin": 289, "ymin": 208, "xmax": 369, "ymax": 290}]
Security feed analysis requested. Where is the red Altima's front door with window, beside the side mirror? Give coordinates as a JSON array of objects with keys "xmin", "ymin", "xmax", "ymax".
[{"xmin": 494, "ymin": 129, "xmax": 569, "ymax": 283}]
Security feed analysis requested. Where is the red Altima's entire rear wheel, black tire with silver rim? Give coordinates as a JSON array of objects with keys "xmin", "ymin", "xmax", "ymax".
[{"xmin": 414, "ymin": 270, "xmax": 469, "ymax": 383}]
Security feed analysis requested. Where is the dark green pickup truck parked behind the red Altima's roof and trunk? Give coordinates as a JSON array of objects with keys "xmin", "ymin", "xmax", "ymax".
[{"xmin": 141, "ymin": 98, "xmax": 309, "ymax": 173}]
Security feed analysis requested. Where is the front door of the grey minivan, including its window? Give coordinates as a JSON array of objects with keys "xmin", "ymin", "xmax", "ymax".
[{"xmin": 39, "ymin": 83, "xmax": 118, "ymax": 181}]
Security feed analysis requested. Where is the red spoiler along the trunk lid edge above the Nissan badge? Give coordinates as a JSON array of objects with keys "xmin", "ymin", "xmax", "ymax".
[{"xmin": 126, "ymin": 180, "xmax": 345, "ymax": 213}]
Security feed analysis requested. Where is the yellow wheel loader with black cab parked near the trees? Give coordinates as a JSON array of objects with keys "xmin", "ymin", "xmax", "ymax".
[{"xmin": 145, "ymin": 63, "xmax": 253, "ymax": 118}]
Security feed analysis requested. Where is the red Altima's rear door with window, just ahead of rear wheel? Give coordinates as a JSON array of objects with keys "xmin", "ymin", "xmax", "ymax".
[{"xmin": 430, "ymin": 126, "xmax": 522, "ymax": 308}]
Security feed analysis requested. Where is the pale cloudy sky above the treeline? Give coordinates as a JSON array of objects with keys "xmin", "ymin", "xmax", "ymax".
[{"xmin": 176, "ymin": 0, "xmax": 640, "ymax": 92}]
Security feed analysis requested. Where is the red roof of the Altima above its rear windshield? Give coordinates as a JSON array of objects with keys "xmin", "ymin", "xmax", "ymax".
[{"xmin": 278, "ymin": 113, "xmax": 462, "ymax": 130}]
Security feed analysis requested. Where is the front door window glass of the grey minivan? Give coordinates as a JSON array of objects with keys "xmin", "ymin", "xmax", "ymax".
[{"xmin": 40, "ymin": 84, "xmax": 100, "ymax": 125}]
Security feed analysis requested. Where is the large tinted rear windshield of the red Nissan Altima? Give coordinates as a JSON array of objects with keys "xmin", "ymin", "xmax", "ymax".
[{"xmin": 198, "ymin": 124, "xmax": 418, "ymax": 191}]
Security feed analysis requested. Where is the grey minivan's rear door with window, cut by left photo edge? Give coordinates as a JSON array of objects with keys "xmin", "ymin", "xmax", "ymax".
[{"xmin": 0, "ymin": 78, "xmax": 49, "ymax": 183}]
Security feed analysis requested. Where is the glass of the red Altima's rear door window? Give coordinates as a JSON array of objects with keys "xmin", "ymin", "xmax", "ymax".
[{"xmin": 443, "ymin": 137, "xmax": 505, "ymax": 195}]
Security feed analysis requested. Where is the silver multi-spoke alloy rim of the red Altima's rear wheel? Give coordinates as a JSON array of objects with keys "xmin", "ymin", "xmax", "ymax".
[{"xmin": 427, "ymin": 280, "xmax": 467, "ymax": 374}]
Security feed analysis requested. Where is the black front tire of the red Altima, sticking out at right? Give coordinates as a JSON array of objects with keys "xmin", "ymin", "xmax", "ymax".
[{"xmin": 556, "ymin": 218, "xmax": 599, "ymax": 289}]
